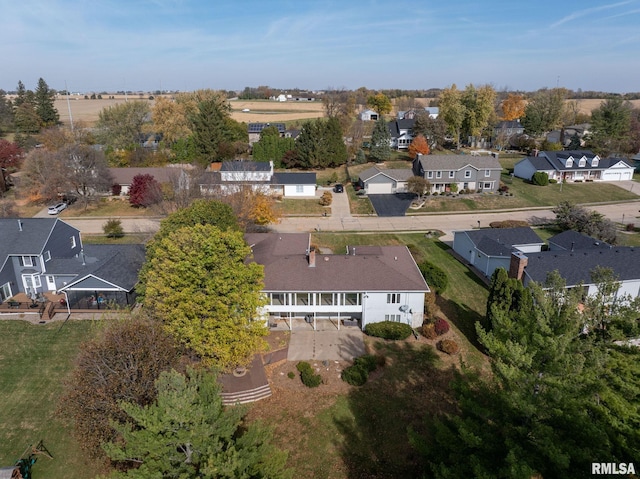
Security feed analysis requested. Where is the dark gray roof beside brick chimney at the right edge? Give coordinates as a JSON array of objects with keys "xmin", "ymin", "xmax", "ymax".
[{"xmin": 524, "ymin": 246, "xmax": 640, "ymax": 286}]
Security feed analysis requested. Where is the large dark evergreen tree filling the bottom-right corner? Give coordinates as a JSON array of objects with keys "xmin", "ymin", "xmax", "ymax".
[{"xmin": 420, "ymin": 273, "xmax": 639, "ymax": 478}]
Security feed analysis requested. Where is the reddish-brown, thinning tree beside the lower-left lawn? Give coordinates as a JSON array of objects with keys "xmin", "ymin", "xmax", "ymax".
[{"xmin": 60, "ymin": 314, "xmax": 179, "ymax": 457}]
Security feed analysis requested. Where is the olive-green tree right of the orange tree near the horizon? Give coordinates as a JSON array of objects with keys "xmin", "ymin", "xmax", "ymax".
[{"xmin": 520, "ymin": 88, "xmax": 568, "ymax": 136}]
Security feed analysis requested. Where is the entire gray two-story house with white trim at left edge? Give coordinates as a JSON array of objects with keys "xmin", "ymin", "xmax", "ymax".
[{"xmin": 0, "ymin": 218, "xmax": 144, "ymax": 305}]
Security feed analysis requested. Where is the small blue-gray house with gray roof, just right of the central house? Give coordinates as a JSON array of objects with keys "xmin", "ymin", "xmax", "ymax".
[{"xmin": 453, "ymin": 227, "xmax": 544, "ymax": 278}]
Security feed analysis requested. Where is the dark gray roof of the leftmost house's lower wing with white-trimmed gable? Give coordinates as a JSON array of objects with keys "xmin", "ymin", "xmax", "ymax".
[{"xmin": 46, "ymin": 244, "xmax": 145, "ymax": 291}]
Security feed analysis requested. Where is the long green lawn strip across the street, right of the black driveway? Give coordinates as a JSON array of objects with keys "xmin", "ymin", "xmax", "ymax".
[{"xmin": 409, "ymin": 175, "xmax": 638, "ymax": 214}]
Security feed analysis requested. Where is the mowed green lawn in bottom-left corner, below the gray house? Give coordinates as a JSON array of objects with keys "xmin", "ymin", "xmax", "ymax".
[{"xmin": 0, "ymin": 320, "xmax": 96, "ymax": 479}]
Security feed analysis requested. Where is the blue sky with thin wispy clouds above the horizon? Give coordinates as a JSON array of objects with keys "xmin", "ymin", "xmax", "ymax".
[{"xmin": 0, "ymin": 0, "xmax": 640, "ymax": 92}]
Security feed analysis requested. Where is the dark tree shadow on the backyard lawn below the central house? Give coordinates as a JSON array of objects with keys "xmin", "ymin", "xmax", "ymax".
[{"xmin": 334, "ymin": 341, "xmax": 453, "ymax": 479}]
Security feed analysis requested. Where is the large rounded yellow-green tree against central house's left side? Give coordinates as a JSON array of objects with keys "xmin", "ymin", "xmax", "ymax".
[{"xmin": 144, "ymin": 225, "xmax": 268, "ymax": 370}]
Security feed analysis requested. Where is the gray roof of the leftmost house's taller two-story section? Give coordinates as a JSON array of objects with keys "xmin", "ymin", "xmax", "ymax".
[{"xmin": 0, "ymin": 218, "xmax": 60, "ymax": 260}]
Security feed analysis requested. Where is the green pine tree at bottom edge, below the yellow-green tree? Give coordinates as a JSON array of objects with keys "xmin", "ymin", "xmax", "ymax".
[{"xmin": 105, "ymin": 370, "xmax": 293, "ymax": 479}]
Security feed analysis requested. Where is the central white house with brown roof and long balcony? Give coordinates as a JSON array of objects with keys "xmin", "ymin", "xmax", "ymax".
[{"xmin": 245, "ymin": 233, "xmax": 429, "ymax": 328}]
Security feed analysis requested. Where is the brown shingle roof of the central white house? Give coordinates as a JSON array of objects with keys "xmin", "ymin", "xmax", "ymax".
[{"xmin": 245, "ymin": 233, "xmax": 429, "ymax": 292}]
